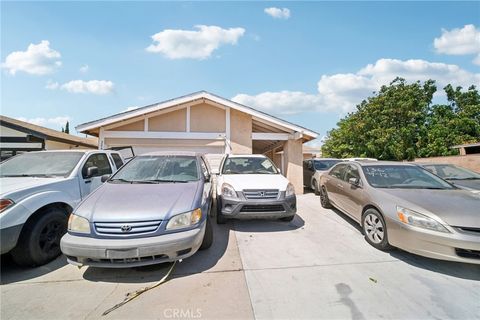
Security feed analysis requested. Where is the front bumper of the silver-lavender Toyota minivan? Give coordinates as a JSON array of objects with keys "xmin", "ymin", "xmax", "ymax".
[{"xmin": 60, "ymin": 222, "xmax": 205, "ymax": 268}]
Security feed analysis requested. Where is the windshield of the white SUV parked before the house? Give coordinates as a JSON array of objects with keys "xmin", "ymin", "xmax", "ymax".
[{"xmin": 222, "ymin": 157, "xmax": 278, "ymax": 174}]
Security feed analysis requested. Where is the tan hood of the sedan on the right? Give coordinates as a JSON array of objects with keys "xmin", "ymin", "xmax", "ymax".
[{"xmin": 383, "ymin": 189, "xmax": 480, "ymax": 228}]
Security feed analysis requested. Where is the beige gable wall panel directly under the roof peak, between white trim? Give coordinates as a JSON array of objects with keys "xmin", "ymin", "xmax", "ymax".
[{"xmin": 190, "ymin": 103, "xmax": 225, "ymax": 132}]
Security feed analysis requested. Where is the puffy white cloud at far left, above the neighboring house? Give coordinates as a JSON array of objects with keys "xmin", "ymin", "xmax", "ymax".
[{"xmin": 2, "ymin": 40, "xmax": 62, "ymax": 75}]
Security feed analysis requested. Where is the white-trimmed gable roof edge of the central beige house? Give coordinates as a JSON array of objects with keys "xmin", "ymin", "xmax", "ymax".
[{"xmin": 75, "ymin": 91, "xmax": 318, "ymax": 139}]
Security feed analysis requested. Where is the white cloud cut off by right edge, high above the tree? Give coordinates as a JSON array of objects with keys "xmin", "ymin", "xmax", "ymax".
[{"xmin": 433, "ymin": 24, "xmax": 480, "ymax": 65}]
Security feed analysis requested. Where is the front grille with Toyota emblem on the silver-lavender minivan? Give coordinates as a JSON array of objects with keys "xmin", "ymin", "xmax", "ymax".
[{"xmin": 94, "ymin": 220, "xmax": 162, "ymax": 236}]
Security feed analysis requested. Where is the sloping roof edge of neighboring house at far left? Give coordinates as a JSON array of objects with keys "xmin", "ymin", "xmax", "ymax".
[{"xmin": 0, "ymin": 115, "xmax": 98, "ymax": 149}]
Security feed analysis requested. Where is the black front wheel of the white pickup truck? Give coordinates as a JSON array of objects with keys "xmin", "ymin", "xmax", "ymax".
[{"xmin": 12, "ymin": 208, "xmax": 67, "ymax": 267}]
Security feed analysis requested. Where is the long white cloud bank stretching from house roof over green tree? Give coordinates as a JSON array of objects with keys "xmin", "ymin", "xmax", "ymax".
[{"xmin": 232, "ymin": 59, "xmax": 480, "ymax": 114}]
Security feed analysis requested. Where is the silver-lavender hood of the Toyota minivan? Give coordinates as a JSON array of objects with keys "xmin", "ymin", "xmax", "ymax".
[{"xmin": 75, "ymin": 182, "xmax": 201, "ymax": 222}]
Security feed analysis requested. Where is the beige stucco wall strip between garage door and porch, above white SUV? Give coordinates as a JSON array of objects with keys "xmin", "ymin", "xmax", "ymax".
[{"xmin": 230, "ymin": 109, "xmax": 252, "ymax": 154}]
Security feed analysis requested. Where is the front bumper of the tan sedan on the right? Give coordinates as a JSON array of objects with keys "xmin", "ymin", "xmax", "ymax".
[{"xmin": 387, "ymin": 219, "xmax": 480, "ymax": 264}]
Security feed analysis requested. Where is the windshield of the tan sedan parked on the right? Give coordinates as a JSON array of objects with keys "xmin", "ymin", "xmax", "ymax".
[{"xmin": 362, "ymin": 165, "xmax": 455, "ymax": 189}]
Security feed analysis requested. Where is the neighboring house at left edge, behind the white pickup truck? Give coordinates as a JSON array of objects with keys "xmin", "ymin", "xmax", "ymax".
[{"xmin": 0, "ymin": 116, "xmax": 98, "ymax": 161}]
